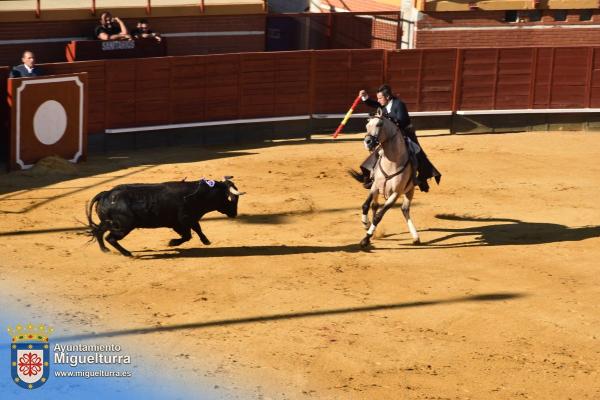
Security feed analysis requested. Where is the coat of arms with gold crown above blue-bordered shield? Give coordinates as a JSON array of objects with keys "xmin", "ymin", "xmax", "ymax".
[{"xmin": 8, "ymin": 324, "xmax": 54, "ymax": 389}]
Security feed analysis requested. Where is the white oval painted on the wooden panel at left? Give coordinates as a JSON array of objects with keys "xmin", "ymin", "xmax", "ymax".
[{"xmin": 33, "ymin": 100, "xmax": 67, "ymax": 146}]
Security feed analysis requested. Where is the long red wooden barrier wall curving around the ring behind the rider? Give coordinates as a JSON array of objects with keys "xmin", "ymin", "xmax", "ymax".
[{"xmin": 8, "ymin": 47, "xmax": 600, "ymax": 139}]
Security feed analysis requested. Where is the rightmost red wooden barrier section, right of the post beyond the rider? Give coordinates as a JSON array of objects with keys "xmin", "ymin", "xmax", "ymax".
[{"xmin": 457, "ymin": 47, "xmax": 600, "ymax": 110}]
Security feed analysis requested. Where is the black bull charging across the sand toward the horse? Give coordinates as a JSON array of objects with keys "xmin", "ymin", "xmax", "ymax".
[{"xmin": 86, "ymin": 178, "xmax": 243, "ymax": 256}]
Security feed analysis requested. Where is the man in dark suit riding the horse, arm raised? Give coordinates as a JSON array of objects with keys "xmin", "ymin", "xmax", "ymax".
[{"xmin": 359, "ymin": 85, "xmax": 442, "ymax": 192}]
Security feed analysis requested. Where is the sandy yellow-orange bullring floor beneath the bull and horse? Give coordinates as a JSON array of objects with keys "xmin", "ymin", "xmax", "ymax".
[{"xmin": 0, "ymin": 132, "xmax": 600, "ymax": 399}]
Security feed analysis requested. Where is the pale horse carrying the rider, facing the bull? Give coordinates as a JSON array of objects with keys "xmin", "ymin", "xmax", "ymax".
[{"xmin": 360, "ymin": 113, "xmax": 420, "ymax": 247}]
